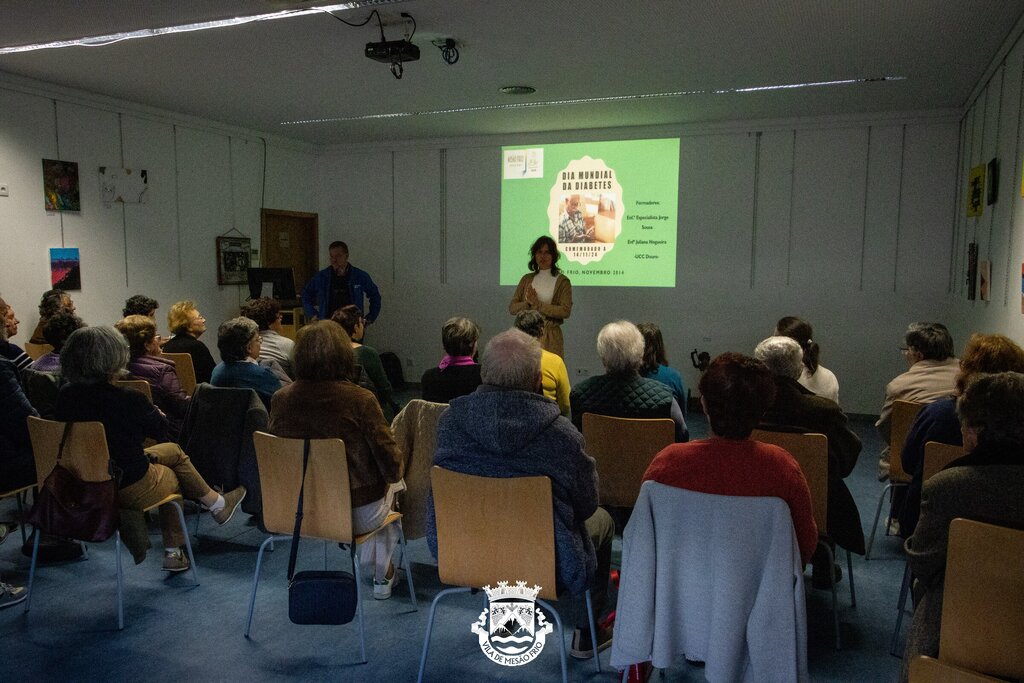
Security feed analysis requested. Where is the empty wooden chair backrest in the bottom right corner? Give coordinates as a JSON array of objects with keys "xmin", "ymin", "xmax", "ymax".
[{"xmin": 939, "ymin": 518, "xmax": 1024, "ymax": 679}]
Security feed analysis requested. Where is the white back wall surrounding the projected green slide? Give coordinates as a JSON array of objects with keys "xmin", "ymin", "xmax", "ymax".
[{"xmin": 319, "ymin": 113, "xmax": 965, "ymax": 413}]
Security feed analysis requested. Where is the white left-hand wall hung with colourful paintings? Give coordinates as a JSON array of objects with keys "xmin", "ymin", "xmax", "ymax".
[{"xmin": 0, "ymin": 80, "xmax": 318, "ymax": 357}]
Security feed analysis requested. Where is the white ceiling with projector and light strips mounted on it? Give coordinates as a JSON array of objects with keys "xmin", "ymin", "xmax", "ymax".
[{"xmin": 0, "ymin": 0, "xmax": 1024, "ymax": 144}]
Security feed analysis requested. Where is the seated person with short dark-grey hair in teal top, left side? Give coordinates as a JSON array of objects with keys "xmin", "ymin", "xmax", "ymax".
[{"xmin": 210, "ymin": 317, "xmax": 281, "ymax": 410}]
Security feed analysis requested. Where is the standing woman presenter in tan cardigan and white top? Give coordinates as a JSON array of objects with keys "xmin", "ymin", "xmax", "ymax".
[{"xmin": 509, "ymin": 234, "xmax": 572, "ymax": 356}]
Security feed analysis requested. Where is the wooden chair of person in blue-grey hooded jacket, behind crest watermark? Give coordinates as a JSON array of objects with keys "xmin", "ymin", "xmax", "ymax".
[{"xmin": 417, "ymin": 466, "xmax": 601, "ymax": 683}]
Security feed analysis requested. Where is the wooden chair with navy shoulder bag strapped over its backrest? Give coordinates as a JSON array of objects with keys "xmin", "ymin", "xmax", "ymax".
[{"xmin": 245, "ymin": 432, "xmax": 417, "ymax": 664}]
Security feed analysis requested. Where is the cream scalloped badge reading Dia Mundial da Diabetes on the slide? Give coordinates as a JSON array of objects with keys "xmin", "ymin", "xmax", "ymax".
[{"xmin": 548, "ymin": 157, "xmax": 624, "ymax": 265}]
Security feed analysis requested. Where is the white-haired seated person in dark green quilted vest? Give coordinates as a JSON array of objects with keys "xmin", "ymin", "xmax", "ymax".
[{"xmin": 569, "ymin": 321, "xmax": 689, "ymax": 441}]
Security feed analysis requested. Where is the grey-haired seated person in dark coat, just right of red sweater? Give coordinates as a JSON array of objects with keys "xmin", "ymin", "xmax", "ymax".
[{"xmin": 754, "ymin": 337, "xmax": 864, "ymax": 588}]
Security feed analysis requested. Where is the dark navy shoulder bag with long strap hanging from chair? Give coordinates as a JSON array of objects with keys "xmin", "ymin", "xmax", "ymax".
[{"xmin": 288, "ymin": 439, "xmax": 356, "ymax": 625}]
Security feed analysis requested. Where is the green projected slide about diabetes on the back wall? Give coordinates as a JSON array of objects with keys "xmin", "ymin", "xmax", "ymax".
[{"xmin": 500, "ymin": 138, "xmax": 679, "ymax": 287}]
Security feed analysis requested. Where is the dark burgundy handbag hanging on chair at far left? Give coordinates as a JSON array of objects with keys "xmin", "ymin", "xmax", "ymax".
[{"xmin": 26, "ymin": 422, "xmax": 118, "ymax": 541}]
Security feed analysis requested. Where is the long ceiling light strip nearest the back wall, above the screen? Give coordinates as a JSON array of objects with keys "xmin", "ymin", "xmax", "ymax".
[{"xmin": 280, "ymin": 76, "xmax": 906, "ymax": 126}]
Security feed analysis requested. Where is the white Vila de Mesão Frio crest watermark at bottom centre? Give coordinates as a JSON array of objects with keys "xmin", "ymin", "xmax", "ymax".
[{"xmin": 471, "ymin": 581, "xmax": 554, "ymax": 667}]
